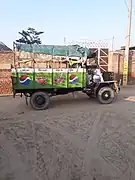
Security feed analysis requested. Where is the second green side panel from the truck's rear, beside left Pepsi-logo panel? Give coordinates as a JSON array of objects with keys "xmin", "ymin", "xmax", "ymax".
[{"xmin": 34, "ymin": 69, "xmax": 53, "ymax": 89}]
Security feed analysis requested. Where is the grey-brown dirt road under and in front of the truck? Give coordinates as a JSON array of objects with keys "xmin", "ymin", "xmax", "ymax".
[{"xmin": 0, "ymin": 88, "xmax": 135, "ymax": 180}]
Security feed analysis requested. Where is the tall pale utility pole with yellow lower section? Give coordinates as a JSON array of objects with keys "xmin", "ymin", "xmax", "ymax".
[{"xmin": 123, "ymin": 0, "xmax": 132, "ymax": 86}]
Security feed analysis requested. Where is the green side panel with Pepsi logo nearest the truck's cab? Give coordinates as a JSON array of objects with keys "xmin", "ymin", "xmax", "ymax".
[{"xmin": 68, "ymin": 68, "xmax": 84, "ymax": 88}]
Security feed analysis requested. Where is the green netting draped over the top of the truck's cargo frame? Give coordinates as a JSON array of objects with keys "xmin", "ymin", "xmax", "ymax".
[{"xmin": 16, "ymin": 44, "xmax": 92, "ymax": 57}]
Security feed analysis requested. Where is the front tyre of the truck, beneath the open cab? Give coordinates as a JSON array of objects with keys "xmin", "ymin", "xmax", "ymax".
[{"xmin": 97, "ymin": 87, "xmax": 115, "ymax": 104}]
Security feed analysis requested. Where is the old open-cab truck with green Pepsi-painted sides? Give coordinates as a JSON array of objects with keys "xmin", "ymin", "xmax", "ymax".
[{"xmin": 11, "ymin": 43, "xmax": 120, "ymax": 110}]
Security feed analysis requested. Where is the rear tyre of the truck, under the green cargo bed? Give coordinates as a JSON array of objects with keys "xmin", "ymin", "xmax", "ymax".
[{"xmin": 30, "ymin": 92, "xmax": 50, "ymax": 110}]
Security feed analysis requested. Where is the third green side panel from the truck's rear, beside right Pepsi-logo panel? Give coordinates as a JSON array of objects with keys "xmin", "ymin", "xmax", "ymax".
[{"xmin": 53, "ymin": 69, "xmax": 68, "ymax": 88}]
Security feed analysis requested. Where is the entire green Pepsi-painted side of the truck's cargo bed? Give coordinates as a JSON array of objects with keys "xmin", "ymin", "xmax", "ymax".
[{"xmin": 12, "ymin": 68, "xmax": 86, "ymax": 90}]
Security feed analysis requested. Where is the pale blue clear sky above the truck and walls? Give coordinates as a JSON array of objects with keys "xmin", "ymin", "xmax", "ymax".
[{"xmin": 0, "ymin": 0, "xmax": 135, "ymax": 49}]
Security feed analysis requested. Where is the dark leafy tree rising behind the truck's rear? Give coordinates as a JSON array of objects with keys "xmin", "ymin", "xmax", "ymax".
[{"xmin": 16, "ymin": 28, "xmax": 44, "ymax": 45}]
